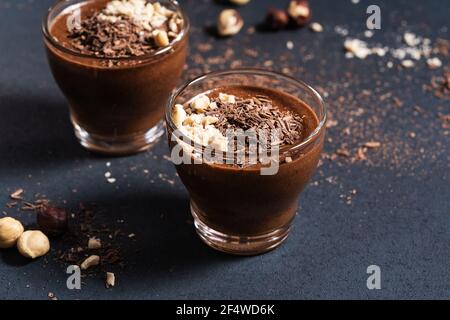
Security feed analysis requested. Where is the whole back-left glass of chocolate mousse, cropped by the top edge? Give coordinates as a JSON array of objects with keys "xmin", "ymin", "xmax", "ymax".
[{"xmin": 43, "ymin": 0, "xmax": 189, "ymax": 155}]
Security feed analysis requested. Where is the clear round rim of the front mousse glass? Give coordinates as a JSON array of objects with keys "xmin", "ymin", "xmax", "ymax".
[{"xmin": 165, "ymin": 68, "xmax": 327, "ymax": 153}]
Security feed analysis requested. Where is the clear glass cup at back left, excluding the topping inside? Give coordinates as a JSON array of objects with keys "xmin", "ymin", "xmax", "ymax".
[{"xmin": 42, "ymin": 0, "xmax": 189, "ymax": 155}]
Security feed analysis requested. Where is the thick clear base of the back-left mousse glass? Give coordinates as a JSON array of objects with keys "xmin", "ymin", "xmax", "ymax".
[{"xmin": 72, "ymin": 119, "xmax": 164, "ymax": 156}]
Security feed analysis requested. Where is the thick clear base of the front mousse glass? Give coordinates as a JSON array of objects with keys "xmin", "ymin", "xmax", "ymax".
[{"xmin": 191, "ymin": 202, "xmax": 291, "ymax": 256}]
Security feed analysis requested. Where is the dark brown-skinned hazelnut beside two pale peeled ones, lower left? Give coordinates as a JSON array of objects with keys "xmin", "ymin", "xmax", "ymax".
[{"xmin": 37, "ymin": 205, "xmax": 67, "ymax": 237}]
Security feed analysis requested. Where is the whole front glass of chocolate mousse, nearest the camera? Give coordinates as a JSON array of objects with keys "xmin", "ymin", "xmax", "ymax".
[{"xmin": 166, "ymin": 69, "xmax": 326, "ymax": 255}]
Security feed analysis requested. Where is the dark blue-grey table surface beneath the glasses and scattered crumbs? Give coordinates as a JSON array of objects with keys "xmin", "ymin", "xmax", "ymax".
[{"xmin": 0, "ymin": 0, "xmax": 450, "ymax": 299}]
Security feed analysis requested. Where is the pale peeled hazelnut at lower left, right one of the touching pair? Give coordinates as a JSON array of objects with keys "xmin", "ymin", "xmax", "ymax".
[{"xmin": 17, "ymin": 230, "xmax": 50, "ymax": 259}]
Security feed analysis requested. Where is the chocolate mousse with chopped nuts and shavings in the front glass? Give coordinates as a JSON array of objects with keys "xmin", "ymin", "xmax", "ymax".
[{"xmin": 168, "ymin": 80, "xmax": 324, "ymax": 254}]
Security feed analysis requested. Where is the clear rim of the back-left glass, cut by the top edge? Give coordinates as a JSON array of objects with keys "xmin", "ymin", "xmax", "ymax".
[{"xmin": 42, "ymin": 0, "xmax": 191, "ymax": 61}]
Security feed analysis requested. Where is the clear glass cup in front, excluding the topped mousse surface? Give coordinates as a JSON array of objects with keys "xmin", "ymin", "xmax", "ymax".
[{"xmin": 166, "ymin": 69, "xmax": 326, "ymax": 255}]
